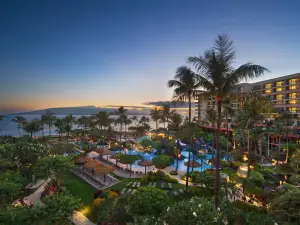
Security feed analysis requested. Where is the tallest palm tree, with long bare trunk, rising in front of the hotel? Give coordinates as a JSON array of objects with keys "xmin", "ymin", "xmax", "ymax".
[{"xmin": 188, "ymin": 35, "xmax": 268, "ymax": 207}]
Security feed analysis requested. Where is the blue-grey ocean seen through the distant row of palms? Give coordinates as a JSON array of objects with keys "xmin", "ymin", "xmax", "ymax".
[{"xmin": 0, "ymin": 115, "xmax": 155, "ymax": 137}]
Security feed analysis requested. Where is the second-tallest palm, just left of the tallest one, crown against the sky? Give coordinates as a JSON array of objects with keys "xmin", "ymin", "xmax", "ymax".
[{"xmin": 168, "ymin": 66, "xmax": 200, "ymax": 123}]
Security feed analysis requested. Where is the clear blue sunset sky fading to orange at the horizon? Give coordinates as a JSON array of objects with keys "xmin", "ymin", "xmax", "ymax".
[{"xmin": 0, "ymin": 0, "xmax": 300, "ymax": 113}]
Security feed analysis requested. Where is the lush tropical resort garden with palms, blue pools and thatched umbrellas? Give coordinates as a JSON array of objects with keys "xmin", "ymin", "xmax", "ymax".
[{"xmin": 0, "ymin": 36, "xmax": 300, "ymax": 225}]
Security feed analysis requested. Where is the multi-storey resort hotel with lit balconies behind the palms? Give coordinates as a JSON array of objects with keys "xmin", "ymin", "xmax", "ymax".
[{"xmin": 195, "ymin": 73, "xmax": 300, "ymax": 149}]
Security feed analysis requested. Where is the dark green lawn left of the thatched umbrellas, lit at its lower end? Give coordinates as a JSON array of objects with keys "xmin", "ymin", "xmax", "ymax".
[{"xmin": 64, "ymin": 172, "xmax": 96, "ymax": 222}]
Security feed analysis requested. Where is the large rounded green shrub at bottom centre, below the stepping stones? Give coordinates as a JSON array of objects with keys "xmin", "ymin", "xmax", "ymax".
[{"xmin": 126, "ymin": 187, "xmax": 170, "ymax": 216}]
